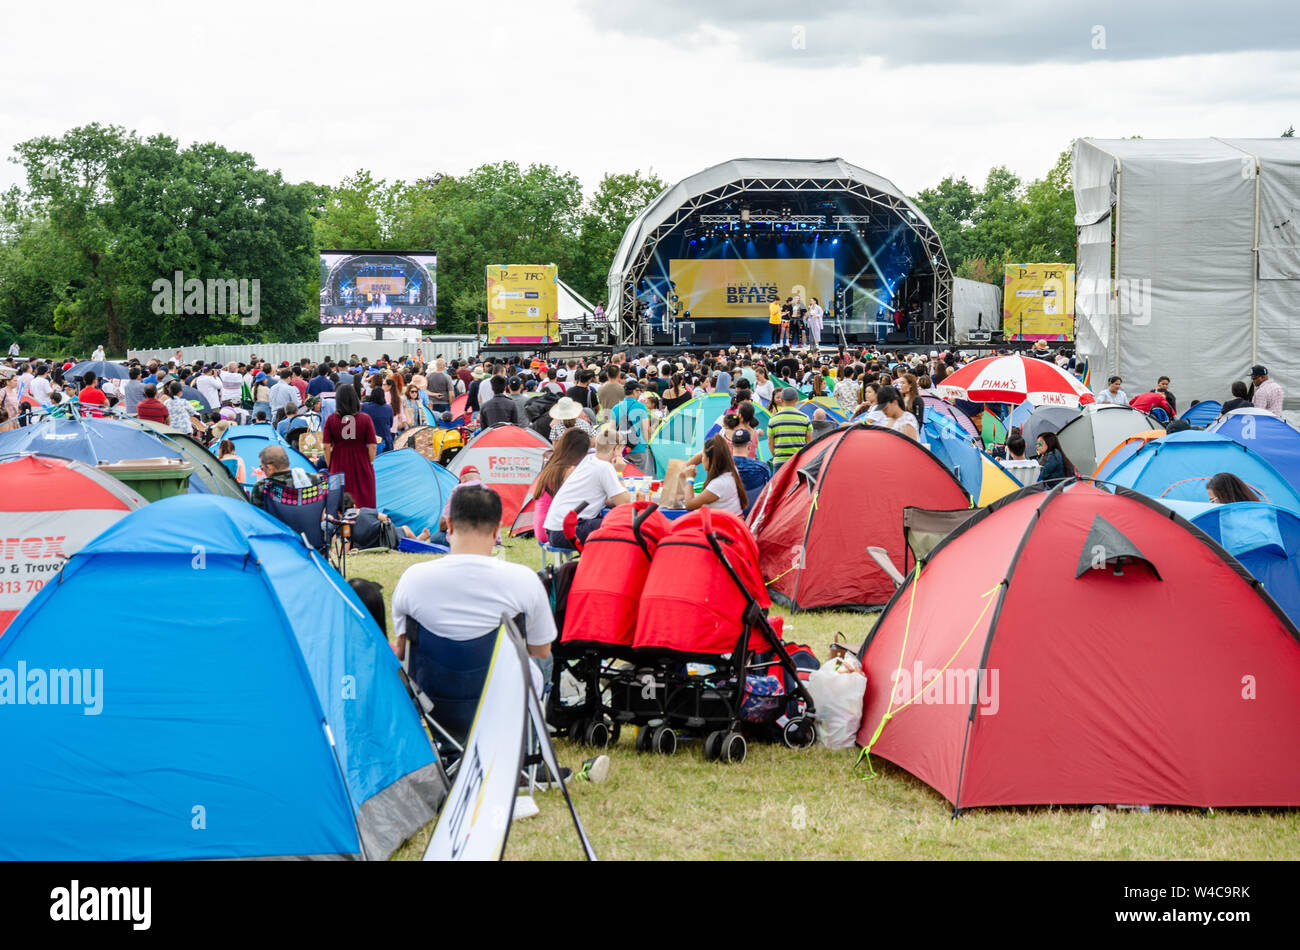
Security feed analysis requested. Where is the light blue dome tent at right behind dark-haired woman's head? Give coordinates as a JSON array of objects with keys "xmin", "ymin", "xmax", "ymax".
[{"xmin": 1105, "ymin": 429, "xmax": 1300, "ymax": 512}]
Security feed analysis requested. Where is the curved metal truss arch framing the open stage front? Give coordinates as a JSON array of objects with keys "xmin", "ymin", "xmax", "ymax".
[{"xmin": 603, "ymin": 178, "xmax": 953, "ymax": 344}]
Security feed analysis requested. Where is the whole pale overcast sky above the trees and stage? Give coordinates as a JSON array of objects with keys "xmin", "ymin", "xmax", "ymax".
[{"xmin": 0, "ymin": 0, "xmax": 1300, "ymax": 194}]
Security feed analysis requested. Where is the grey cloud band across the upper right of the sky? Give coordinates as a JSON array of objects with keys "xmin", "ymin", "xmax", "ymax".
[{"xmin": 579, "ymin": 0, "xmax": 1300, "ymax": 68}]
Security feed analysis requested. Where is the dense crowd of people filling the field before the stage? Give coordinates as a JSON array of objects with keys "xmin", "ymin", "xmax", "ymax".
[{"xmin": 0, "ymin": 340, "xmax": 1283, "ymax": 527}]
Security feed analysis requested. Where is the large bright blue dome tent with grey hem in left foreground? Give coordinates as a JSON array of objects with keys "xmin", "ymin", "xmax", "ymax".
[{"xmin": 0, "ymin": 495, "xmax": 446, "ymax": 860}]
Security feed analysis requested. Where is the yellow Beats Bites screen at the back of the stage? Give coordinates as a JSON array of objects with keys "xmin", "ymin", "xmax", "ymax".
[{"xmin": 668, "ymin": 257, "xmax": 835, "ymax": 322}]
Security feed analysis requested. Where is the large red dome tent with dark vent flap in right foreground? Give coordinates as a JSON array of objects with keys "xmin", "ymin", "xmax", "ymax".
[{"xmin": 858, "ymin": 481, "xmax": 1300, "ymax": 811}]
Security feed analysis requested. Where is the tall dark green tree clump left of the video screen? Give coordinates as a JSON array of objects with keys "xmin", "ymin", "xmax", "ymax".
[{"xmin": 0, "ymin": 125, "xmax": 321, "ymax": 353}]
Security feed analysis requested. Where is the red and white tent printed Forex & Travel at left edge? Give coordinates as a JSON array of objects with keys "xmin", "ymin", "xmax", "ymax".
[{"xmin": 0, "ymin": 455, "xmax": 146, "ymax": 633}]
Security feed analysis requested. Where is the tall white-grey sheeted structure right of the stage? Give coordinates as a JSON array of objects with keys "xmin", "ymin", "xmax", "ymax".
[{"xmin": 1073, "ymin": 138, "xmax": 1300, "ymax": 409}]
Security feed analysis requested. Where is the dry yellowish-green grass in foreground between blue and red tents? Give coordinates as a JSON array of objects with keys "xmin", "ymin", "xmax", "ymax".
[{"xmin": 348, "ymin": 541, "xmax": 1300, "ymax": 860}]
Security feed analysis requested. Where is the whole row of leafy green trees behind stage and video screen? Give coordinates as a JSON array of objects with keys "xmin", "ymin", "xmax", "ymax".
[{"xmin": 0, "ymin": 123, "xmax": 1097, "ymax": 355}]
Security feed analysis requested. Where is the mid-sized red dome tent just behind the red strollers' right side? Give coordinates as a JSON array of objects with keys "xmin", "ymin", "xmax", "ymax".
[{"xmin": 750, "ymin": 425, "xmax": 970, "ymax": 610}]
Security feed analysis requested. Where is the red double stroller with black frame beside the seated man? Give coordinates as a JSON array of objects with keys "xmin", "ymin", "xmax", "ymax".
[{"xmin": 551, "ymin": 506, "xmax": 816, "ymax": 762}]
